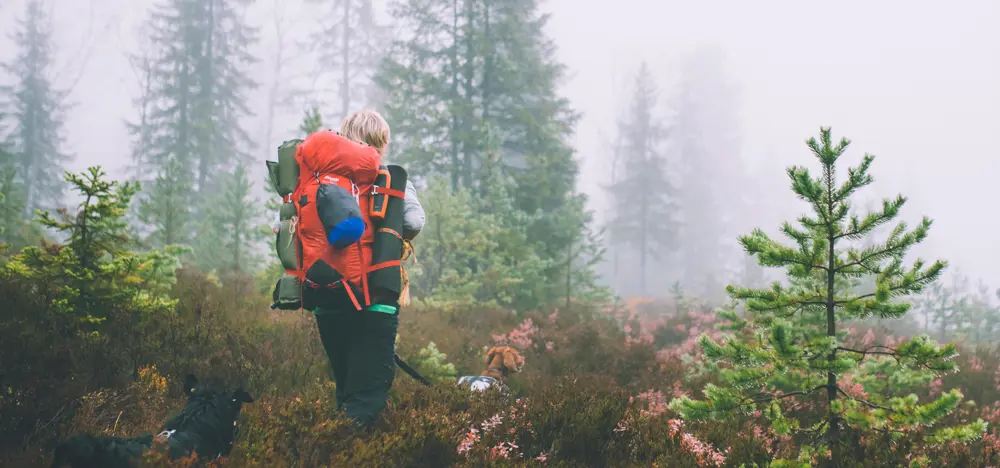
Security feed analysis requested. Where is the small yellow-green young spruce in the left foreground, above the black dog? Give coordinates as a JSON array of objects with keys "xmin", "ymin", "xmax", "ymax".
[{"xmin": 9, "ymin": 167, "xmax": 181, "ymax": 328}]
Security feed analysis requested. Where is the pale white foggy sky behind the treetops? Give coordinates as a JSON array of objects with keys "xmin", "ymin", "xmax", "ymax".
[{"xmin": 0, "ymin": 0, "xmax": 1000, "ymax": 287}]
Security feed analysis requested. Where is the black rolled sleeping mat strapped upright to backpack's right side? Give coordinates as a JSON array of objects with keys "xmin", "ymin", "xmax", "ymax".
[{"xmin": 368, "ymin": 165, "xmax": 406, "ymax": 303}]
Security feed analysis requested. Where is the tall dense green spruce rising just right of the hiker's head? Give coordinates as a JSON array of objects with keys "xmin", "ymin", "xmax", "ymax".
[{"xmin": 376, "ymin": 0, "xmax": 589, "ymax": 306}]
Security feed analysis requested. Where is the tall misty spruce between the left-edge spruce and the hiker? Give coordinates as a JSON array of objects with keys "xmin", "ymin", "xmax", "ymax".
[{"xmin": 130, "ymin": 0, "xmax": 257, "ymax": 260}]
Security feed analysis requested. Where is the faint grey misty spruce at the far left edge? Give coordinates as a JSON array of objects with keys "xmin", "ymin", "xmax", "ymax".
[{"xmin": 4, "ymin": 0, "xmax": 71, "ymax": 212}]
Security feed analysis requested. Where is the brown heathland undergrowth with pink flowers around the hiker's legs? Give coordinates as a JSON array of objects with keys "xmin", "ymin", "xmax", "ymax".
[{"xmin": 0, "ymin": 276, "xmax": 1000, "ymax": 467}]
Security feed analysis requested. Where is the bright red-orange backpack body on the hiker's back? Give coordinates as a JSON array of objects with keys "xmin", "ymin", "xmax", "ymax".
[{"xmin": 287, "ymin": 130, "xmax": 404, "ymax": 310}]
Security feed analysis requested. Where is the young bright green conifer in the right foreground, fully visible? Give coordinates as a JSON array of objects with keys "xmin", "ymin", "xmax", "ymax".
[{"xmin": 670, "ymin": 128, "xmax": 986, "ymax": 466}]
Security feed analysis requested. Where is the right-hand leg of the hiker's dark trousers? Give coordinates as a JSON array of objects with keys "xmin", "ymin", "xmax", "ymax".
[{"xmin": 344, "ymin": 311, "xmax": 399, "ymax": 425}]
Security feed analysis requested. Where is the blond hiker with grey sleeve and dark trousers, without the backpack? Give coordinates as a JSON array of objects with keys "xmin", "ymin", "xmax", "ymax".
[{"xmin": 303, "ymin": 110, "xmax": 426, "ymax": 426}]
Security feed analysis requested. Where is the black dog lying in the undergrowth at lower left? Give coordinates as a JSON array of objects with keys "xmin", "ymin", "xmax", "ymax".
[{"xmin": 52, "ymin": 375, "xmax": 254, "ymax": 468}]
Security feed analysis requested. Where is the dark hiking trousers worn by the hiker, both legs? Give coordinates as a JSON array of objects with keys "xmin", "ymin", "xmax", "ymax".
[{"xmin": 316, "ymin": 304, "xmax": 399, "ymax": 426}]
